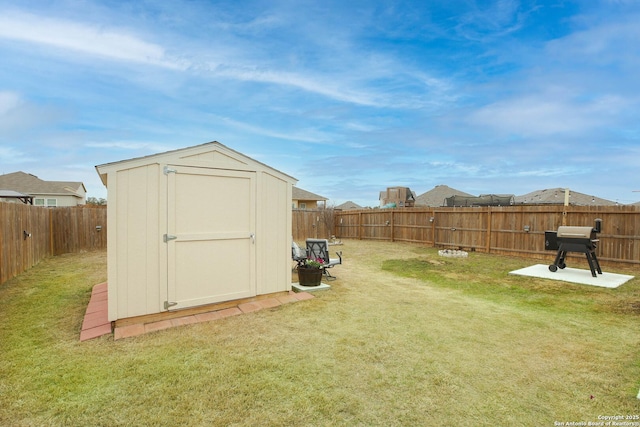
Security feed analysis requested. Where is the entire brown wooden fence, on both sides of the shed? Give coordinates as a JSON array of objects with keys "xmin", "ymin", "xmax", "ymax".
[{"xmin": 5, "ymin": 203, "xmax": 640, "ymax": 284}]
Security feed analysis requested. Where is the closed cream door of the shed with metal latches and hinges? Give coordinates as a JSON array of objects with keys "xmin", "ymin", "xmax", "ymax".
[{"xmin": 165, "ymin": 166, "xmax": 256, "ymax": 309}]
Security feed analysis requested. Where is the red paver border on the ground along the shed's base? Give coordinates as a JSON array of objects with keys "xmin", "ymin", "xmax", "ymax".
[{"xmin": 80, "ymin": 283, "xmax": 313, "ymax": 341}]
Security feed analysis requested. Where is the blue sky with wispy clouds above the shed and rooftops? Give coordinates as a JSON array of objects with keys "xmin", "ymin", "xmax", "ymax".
[{"xmin": 0, "ymin": 0, "xmax": 640, "ymax": 206}]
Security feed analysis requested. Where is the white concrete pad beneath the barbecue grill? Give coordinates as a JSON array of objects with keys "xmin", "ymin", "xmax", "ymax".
[{"xmin": 509, "ymin": 264, "xmax": 634, "ymax": 288}]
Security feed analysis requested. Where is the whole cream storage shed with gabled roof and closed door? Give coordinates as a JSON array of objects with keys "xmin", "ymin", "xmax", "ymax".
[{"xmin": 96, "ymin": 141, "xmax": 297, "ymax": 321}]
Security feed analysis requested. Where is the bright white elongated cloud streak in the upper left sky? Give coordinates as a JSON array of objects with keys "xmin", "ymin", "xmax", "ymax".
[{"xmin": 0, "ymin": 12, "xmax": 188, "ymax": 69}]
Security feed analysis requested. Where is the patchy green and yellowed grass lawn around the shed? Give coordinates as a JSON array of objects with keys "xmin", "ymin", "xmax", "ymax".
[{"xmin": 0, "ymin": 241, "xmax": 640, "ymax": 426}]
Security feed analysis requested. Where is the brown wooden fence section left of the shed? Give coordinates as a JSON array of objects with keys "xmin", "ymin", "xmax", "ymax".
[{"xmin": 0, "ymin": 203, "xmax": 107, "ymax": 284}]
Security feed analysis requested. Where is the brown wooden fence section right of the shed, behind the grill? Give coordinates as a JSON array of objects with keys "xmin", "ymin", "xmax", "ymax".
[{"xmin": 330, "ymin": 205, "xmax": 640, "ymax": 264}]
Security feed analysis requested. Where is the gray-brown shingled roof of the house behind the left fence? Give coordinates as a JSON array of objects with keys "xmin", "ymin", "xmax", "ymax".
[{"xmin": 0, "ymin": 172, "xmax": 87, "ymax": 199}]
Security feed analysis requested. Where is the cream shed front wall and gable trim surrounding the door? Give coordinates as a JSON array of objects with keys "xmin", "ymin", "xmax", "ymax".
[{"xmin": 97, "ymin": 143, "xmax": 295, "ymax": 321}]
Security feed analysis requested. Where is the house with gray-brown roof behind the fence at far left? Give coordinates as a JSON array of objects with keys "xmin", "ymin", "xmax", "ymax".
[{"xmin": 0, "ymin": 171, "xmax": 87, "ymax": 207}]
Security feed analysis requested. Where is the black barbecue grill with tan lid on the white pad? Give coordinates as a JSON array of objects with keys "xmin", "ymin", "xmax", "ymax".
[{"xmin": 545, "ymin": 219, "xmax": 602, "ymax": 277}]
